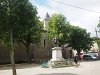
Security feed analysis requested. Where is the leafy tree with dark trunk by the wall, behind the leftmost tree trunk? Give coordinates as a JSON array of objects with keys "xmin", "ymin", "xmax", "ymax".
[{"xmin": 13, "ymin": 0, "xmax": 42, "ymax": 63}]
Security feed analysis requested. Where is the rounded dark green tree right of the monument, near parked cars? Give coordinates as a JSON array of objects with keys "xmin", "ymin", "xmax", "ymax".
[{"xmin": 68, "ymin": 26, "xmax": 93, "ymax": 58}]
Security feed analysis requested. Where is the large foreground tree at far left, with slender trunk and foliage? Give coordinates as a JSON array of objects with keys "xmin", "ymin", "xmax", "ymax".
[{"xmin": 0, "ymin": 0, "xmax": 42, "ymax": 75}]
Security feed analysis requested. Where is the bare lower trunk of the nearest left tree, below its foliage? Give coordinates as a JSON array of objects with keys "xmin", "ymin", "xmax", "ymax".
[{"xmin": 10, "ymin": 31, "xmax": 17, "ymax": 75}]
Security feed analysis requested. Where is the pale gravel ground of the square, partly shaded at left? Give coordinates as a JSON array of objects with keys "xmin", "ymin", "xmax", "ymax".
[{"xmin": 0, "ymin": 61, "xmax": 100, "ymax": 75}]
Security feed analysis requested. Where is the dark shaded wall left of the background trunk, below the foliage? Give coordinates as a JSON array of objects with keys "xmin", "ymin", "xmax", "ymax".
[{"xmin": 0, "ymin": 43, "xmax": 26, "ymax": 64}]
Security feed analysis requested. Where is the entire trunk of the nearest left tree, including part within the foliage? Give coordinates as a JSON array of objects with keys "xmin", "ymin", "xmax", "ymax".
[{"xmin": 7, "ymin": 0, "xmax": 17, "ymax": 75}]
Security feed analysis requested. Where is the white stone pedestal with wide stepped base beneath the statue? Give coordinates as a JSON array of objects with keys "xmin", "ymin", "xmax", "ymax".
[{"xmin": 48, "ymin": 47, "xmax": 69, "ymax": 68}]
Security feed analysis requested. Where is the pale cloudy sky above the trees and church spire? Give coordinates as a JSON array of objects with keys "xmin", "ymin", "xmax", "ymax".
[{"xmin": 30, "ymin": 0, "xmax": 100, "ymax": 37}]
